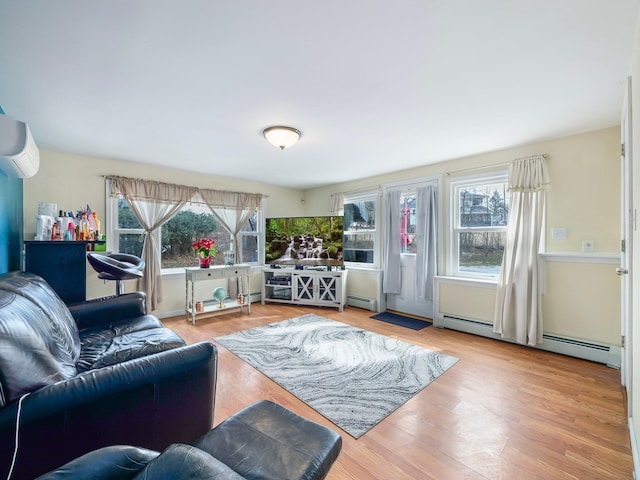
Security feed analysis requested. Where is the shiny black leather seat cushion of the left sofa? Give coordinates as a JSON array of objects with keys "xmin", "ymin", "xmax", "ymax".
[{"xmin": 76, "ymin": 327, "xmax": 186, "ymax": 372}]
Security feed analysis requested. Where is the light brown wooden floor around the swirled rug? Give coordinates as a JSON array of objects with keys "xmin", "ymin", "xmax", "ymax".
[{"xmin": 163, "ymin": 303, "xmax": 633, "ymax": 480}]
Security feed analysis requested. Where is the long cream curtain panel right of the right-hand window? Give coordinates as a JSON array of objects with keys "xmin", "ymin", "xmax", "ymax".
[{"xmin": 493, "ymin": 154, "xmax": 549, "ymax": 346}]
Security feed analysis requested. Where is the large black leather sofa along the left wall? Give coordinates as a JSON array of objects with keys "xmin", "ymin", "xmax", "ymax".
[{"xmin": 0, "ymin": 272, "xmax": 217, "ymax": 480}]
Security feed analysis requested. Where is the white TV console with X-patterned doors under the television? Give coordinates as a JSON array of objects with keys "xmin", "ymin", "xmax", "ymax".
[{"xmin": 261, "ymin": 268, "xmax": 347, "ymax": 311}]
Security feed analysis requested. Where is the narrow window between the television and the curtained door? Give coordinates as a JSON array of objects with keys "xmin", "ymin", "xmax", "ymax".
[{"xmin": 342, "ymin": 191, "xmax": 380, "ymax": 267}]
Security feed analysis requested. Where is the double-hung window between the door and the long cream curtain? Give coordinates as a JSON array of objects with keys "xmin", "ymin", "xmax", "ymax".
[{"xmin": 447, "ymin": 173, "xmax": 509, "ymax": 278}]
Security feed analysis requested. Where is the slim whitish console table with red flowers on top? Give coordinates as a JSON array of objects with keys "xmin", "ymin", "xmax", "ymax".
[{"xmin": 184, "ymin": 265, "xmax": 251, "ymax": 325}]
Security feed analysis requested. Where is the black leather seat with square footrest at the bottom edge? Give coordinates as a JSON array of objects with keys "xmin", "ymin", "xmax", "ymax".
[{"xmin": 38, "ymin": 400, "xmax": 342, "ymax": 480}]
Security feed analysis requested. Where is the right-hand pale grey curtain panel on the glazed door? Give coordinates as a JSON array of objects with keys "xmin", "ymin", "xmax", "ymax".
[{"xmin": 416, "ymin": 185, "xmax": 437, "ymax": 301}]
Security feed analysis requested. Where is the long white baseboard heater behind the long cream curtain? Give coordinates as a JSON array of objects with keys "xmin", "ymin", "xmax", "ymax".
[{"xmin": 438, "ymin": 314, "xmax": 621, "ymax": 368}]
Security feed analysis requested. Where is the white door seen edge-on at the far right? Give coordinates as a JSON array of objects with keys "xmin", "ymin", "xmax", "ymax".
[{"xmin": 616, "ymin": 78, "xmax": 635, "ymax": 410}]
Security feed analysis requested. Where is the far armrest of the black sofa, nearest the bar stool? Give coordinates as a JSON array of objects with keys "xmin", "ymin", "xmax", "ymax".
[{"xmin": 69, "ymin": 292, "xmax": 147, "ymax": 329}]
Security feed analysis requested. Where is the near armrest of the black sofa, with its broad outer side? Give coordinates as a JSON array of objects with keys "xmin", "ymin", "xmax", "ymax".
[{"xmin": 0, "ymin": 342, "xmax": 217, "ymax": 478}]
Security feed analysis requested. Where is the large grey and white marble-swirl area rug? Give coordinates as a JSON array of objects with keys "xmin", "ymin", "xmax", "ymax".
[{"xmin": 215, "ymin": 314, "xmax": 458, "ymax": 438}]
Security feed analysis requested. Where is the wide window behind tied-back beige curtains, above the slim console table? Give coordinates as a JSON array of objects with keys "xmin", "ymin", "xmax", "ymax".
[{"xmin": 107, "ymin": 198, "xmax": 261, "ymax": 269}]
